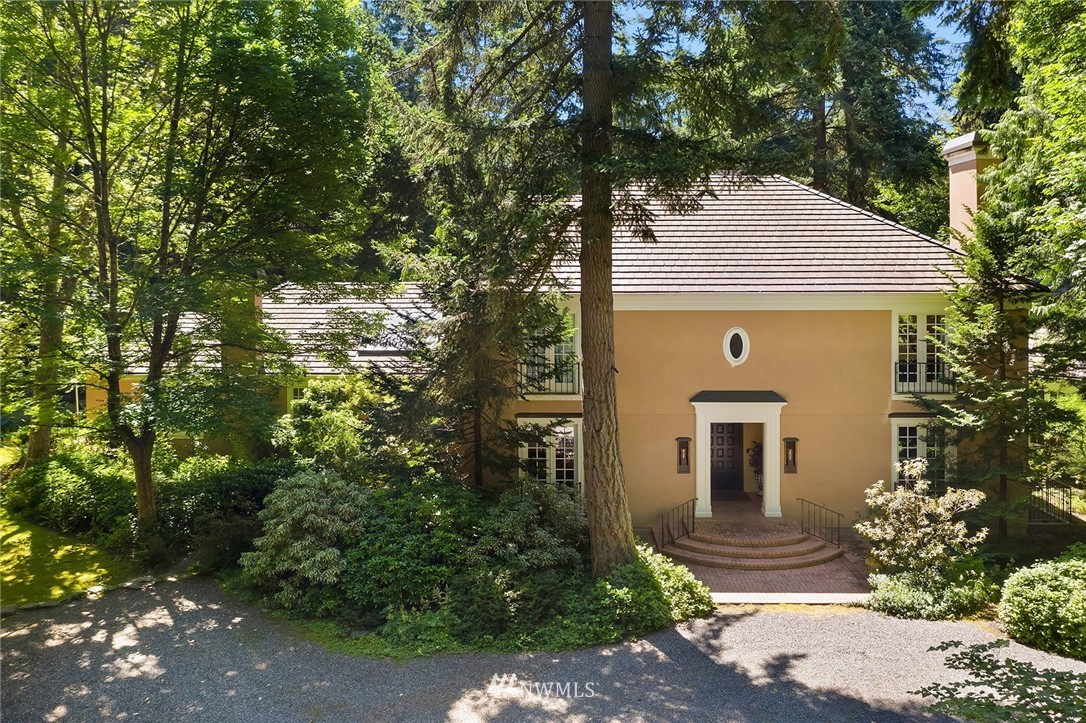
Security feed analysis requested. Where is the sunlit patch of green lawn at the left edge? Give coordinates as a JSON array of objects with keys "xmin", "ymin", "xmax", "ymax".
[{"xmin": 0, "ymin": 511, "xmax": 136, "ymax": 605}]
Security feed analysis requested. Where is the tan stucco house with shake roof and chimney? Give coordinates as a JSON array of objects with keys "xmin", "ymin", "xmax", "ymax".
[{"xmin": 91, "ymin": 135, "xmax": 988, "ymax": 527}]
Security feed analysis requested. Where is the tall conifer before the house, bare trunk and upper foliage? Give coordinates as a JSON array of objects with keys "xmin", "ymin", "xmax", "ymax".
[{"xmin": 384, "ymin": 2, "xmax": 837, "ymax": 575}]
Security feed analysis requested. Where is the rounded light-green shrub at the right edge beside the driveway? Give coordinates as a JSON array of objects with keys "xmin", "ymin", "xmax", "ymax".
[{"xmin": 999, "ymin": 559, "xmax": 1086, "ymax": 660}]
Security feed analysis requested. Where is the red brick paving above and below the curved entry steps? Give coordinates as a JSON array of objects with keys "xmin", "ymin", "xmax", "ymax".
[{"xmin": 686, "ymin": 498, "xmax": 871, "ymax": 595}]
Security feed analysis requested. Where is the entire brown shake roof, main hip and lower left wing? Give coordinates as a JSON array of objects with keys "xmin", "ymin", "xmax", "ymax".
[{"xmin": 263, "ymin": 176, "xmax": 961, "ymax": 373}]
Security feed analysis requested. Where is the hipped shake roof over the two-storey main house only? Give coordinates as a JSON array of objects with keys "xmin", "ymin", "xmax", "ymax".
[{"xmin": 558, "ymin": 176, "xmax": 961, "ymax": 294}]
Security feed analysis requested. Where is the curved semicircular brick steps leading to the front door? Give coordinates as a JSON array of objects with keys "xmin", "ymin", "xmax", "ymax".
[{"xmin": 660, "ymin": 531, "xmax": 844, "ymax": 570}]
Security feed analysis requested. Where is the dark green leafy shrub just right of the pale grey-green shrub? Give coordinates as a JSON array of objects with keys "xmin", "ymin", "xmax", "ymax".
[{"xmin": 343, "ymin": 477, "xmax": 481, "ymax": 611}]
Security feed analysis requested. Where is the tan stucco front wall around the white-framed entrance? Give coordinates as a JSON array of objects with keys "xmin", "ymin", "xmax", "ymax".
[{"xmin": 516, "ymin": 309, "xmax": 917, "ymax": 525}]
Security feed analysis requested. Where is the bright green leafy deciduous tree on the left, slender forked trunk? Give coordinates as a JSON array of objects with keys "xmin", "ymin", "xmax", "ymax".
[{"xmin": 2, "ymin": 0, "xmax": 390, "ymax": 525}]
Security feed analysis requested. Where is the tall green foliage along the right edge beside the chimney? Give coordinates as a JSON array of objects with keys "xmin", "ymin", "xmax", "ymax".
[{"xmin": 916, "ymin": 2, "xmax": 1086, "ymax": 533}]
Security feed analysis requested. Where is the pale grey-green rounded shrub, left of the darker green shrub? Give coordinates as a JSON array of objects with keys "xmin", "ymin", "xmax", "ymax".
[{"xmin": 241, "ymin": 470, "xmax": 371, "ymax": 616}]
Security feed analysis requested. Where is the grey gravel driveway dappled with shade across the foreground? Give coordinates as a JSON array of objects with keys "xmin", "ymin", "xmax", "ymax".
[{"xmin": 0, "ymin": 580, "xmax": 1086, "ymax": 723}]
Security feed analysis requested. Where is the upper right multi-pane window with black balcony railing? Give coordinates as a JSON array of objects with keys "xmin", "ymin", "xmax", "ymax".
[{"xmin": 894, "ymin": 314, "xmax": 954, "ymax": 394}]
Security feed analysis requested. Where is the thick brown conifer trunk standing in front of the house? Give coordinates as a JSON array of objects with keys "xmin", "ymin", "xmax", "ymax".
[{"xmin": 580, "ymin": 1, "xmax": 635, "ymax": 576}]
